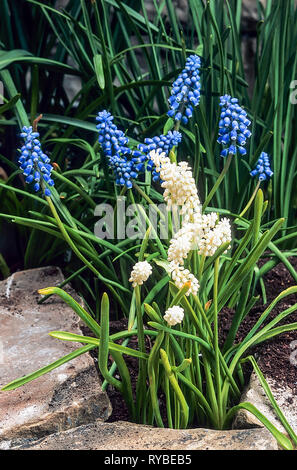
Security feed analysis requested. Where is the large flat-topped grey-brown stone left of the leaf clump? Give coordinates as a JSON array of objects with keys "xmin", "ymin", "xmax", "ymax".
[{"xmin": 0, "ymin": 267, "xmax": 111, "ymax": 447}]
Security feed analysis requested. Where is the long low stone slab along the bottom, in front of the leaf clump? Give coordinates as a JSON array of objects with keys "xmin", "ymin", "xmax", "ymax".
[{"xmin": 11, "ymin": 421, "xmax": 278, "ymax": 451}]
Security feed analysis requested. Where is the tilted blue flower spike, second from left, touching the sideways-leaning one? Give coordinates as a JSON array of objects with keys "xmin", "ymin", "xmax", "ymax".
[{"xmin": 96, "ymin": 110, "xmax": 146, "ymax": 189}]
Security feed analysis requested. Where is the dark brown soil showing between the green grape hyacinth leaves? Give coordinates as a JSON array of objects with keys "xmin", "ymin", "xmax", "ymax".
[{"xmin": 89, "ymin": 257, "xmax": 297, "ymax": 422}]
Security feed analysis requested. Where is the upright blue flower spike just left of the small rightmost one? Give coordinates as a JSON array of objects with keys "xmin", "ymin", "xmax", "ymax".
[{"xmin": 218, "ymin": 95, "xmax": 251, "ymax": 157}]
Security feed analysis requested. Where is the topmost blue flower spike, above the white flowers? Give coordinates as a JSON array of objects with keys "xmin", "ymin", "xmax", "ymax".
[{"xmin": 167, "ymin": 55, "xmax": 201, "ymax": 124}]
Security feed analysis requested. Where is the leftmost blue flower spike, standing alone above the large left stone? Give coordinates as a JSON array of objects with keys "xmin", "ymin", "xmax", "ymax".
[{"xmin": 19, "ymin": 126, "xmax": 54, "ymax": 196}]
